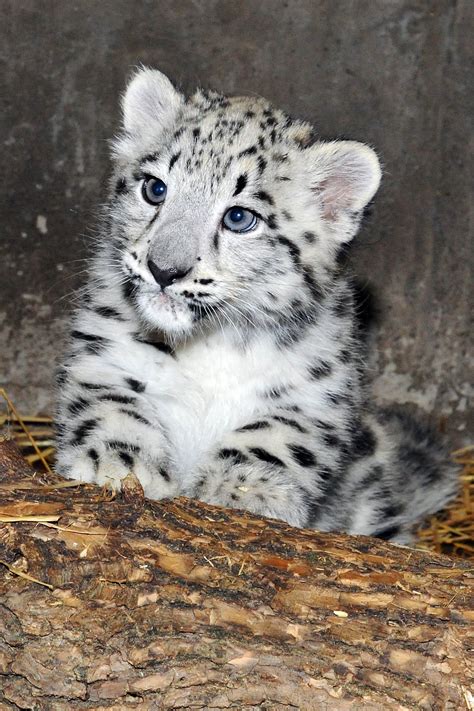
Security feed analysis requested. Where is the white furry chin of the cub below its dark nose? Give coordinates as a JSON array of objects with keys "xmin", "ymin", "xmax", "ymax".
[{"xmin": 135, "ymin": 292, "xmax": 194, "ymax": 340}]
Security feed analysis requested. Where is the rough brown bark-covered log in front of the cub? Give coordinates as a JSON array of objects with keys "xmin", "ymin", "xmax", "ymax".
[{"xmin": 0, "ymin": 442, "xmax": 474, "ymax": 711}]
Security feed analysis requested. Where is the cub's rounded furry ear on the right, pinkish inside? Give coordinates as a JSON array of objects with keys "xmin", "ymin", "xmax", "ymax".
[{"xmin": 304, "ymin": 141, "xmax": 382, "ymax": 242}]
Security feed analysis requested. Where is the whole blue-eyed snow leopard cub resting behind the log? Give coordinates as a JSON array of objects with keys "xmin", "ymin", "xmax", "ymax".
[{"xmin": 53, "ymin": 69, "xmax": 456, "ymax": 542}]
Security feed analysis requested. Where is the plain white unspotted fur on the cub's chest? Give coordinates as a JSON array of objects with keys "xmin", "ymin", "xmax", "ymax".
[{"xmin": 142, "ymin": 335, "xmax": 292, "ymax": 472}]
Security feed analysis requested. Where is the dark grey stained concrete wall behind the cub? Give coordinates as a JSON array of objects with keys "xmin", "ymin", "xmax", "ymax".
[{"xmin": 0, "ymin": 0, "xmax": 474, "ymax": 438}]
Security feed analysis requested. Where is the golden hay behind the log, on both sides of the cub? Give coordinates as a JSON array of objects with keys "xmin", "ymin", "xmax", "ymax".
[{"xmin": 0, "ymin": 389, "xmax": 474, "ymax": 560}]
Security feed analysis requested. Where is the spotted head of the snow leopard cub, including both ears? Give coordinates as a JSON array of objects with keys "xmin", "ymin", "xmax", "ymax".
[{"xmin": 109, "ymin": 69, "xmax": 380, "ymax": 339}]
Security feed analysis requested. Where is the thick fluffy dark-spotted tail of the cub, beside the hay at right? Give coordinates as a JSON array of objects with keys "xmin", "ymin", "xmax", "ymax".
[{"xmin": 340, "ymin": 408, "xmax": 459, "ymax": 543}]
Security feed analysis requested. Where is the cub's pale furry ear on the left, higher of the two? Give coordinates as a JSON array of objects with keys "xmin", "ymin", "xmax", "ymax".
[{"xmin": 122, "ymin": 67, "xmax": 184, "ymax": 135}]
